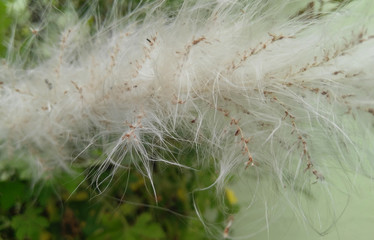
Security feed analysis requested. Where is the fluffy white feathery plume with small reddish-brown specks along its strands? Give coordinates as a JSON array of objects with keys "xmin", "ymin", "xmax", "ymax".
[{"xmin": 0, "ymin": 0, "xmax": 374, "ymax": 237}]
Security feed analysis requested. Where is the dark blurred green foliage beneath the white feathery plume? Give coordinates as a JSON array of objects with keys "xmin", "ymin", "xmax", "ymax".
[{"xmin": 0, "ymin": 152, "xmax": 237, "ymax": 240}]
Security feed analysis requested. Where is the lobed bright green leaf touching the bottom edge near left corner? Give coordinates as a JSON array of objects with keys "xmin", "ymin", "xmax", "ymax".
[{"xmin": 11, "ymin": 207, "xmax": 49, "ymax": 239}]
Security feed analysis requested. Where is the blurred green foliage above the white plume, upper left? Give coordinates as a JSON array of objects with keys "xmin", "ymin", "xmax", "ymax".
[{"xmin": 0, "ymin": 0, "xmax": 182, "ymax": 63}]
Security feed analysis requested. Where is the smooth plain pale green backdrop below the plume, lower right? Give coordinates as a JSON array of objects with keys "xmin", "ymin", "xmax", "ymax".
[{"xmin": 232, "ymin": 172, "xmax": 374, "ymax": 240}]
